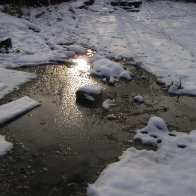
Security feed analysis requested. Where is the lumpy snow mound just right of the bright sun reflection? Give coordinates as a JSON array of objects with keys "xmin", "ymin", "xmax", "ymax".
[{"xmin": 91, "ymin": 59, "xmax": 131, "ymax": 80}]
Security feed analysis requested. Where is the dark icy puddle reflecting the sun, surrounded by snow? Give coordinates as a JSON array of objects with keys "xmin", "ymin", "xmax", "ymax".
[{"xmin": 0, "ymin": 58, "xmax": 196, "ymax": 196}]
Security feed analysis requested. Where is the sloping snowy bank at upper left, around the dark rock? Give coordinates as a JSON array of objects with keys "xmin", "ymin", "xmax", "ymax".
[{"xmin": 0, "ymin": 12, "xmax": 67, "ymax": 68}]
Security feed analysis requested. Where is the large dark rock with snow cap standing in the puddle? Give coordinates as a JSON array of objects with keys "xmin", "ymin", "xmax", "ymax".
[{"xmin": 76, "ymin": 85, "xmax": 102, "ymax": 105}]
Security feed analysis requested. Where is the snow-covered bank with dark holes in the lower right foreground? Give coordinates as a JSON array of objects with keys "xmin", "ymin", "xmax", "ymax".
[{"xmin": 87, "ymin": 117, "xmax": 196, "ymax": 196}]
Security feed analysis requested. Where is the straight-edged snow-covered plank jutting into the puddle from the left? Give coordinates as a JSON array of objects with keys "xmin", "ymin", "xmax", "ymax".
[{"xmin": 0, "ymin": 96, "xmax": 40, "ymax": 124}]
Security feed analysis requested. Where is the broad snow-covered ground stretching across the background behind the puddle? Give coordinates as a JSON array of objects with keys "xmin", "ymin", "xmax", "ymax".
[{"xmin": 0, "ymin": 0, "xmax": 196, "ymax": 96}]
